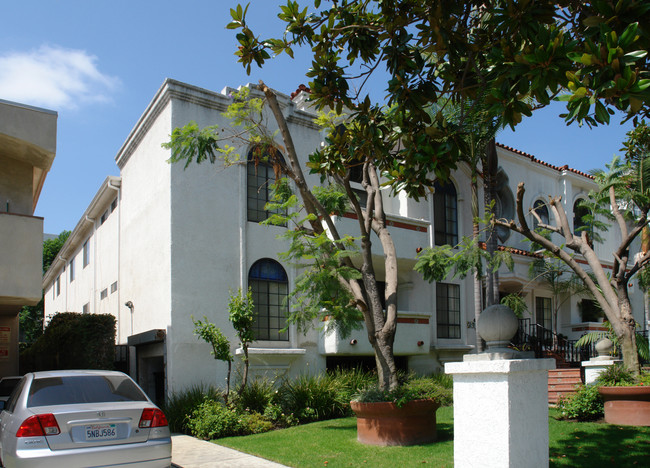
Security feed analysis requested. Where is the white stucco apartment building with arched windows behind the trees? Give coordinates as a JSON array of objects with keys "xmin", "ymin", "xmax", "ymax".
[{"xmin": 44, "ymin": 80, "xmax": 642, "ymax": 399}]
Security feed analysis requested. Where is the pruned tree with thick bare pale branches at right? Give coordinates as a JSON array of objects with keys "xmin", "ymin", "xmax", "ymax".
[{"xmin": 495, "ymin": 123, "xmax": 650, "ymax": 374}]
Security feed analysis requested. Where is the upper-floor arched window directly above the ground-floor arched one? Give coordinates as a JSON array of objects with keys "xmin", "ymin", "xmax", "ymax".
[{"xmin": 246, "ymin": 146, "xmax": 282, "ymax": 223}]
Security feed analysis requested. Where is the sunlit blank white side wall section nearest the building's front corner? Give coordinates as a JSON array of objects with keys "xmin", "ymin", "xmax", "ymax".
[{"xmin": 118, "ymin": 106, "xmax": 171, "ymax": 343}]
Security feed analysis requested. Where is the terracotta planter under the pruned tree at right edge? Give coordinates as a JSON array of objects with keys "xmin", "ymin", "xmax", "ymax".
[{"xmin": 598, "ymin": 386, "xmax": 650, "ymax": 426}]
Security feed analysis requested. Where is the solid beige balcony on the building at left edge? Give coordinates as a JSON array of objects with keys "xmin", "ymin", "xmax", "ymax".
[{"xmin": 0, "ymin": 213, "xmax": 43, "ymax": 310}]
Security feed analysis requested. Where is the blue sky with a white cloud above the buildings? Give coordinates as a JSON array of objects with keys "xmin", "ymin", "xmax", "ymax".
[{"xmin": 0, "ymin": 0, "xmax": 631, "ymax": 233}]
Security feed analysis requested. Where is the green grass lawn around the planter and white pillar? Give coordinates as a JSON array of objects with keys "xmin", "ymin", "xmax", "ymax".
[{"xmin": 218, "ymin": 407, "xmax": 650, "ymax": 468}]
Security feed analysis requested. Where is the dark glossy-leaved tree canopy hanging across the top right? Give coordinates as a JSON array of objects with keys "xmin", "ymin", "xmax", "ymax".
[{"xmin": 228, "ymin": 0, "xmax": 650, "ymax": 197}]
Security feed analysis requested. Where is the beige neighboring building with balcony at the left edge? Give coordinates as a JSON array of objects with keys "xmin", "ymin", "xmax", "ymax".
[{"xmin": 0, "ymin": 100, "xmax": 57, "ymax": 377}]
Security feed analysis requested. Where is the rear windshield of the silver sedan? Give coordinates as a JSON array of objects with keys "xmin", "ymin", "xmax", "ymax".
[{"xmin": 27, "ymin": 375, "xmax": 147, "ymax": 408}]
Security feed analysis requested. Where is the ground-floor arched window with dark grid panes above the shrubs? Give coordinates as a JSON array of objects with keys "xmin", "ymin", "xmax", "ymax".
[{"xmin": 248, "ymin": 258, "xmax": 289, "ymax": 341}]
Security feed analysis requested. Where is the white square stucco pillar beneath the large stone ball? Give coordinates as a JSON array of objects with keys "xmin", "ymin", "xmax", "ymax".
[{"xmin": 445, "ymin": 355, "xmax": 555, "ymax": 468}]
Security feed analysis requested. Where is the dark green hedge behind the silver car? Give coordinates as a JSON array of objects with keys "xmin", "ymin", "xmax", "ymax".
[{"xmin": 20, "ymin": 312, "xmax": 115, "ymax": 373}]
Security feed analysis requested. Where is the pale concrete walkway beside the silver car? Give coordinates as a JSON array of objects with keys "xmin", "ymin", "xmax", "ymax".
[{"xmin": 172, "ymin": 434, "xmax": 284, "ymax": 468}]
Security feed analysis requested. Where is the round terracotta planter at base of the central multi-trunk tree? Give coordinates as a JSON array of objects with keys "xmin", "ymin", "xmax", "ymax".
[{"xmin": 350, "ymin": 400, "xmax": 440, "ymax": 445}]
